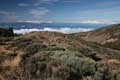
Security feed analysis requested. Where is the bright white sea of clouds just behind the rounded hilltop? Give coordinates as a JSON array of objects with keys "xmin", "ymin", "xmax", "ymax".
[{"xmin": 14, "ymin": 28, "xmax": 93, "ymax": 34}]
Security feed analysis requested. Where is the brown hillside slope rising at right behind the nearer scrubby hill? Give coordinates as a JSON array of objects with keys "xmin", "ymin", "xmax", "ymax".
[{"xmin": 76, "ymin": 24, "xmax": 120, "ymax": 50}]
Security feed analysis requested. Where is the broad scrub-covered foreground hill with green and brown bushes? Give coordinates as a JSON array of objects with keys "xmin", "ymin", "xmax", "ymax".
[{"xmin": 0, "ymin": 27, "xmax": 120, "ymax": 80}]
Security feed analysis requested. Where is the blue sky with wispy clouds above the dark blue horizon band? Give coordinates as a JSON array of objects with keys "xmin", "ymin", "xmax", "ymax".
[{"xmin": 0, "ymin": 0, "xmax": 120, "ymax": 24}]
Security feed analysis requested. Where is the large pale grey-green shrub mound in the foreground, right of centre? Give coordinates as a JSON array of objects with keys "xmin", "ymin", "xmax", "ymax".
[{"xmin": 52, "ymin": 51, "xmax": 96, "ymax": 76}]
